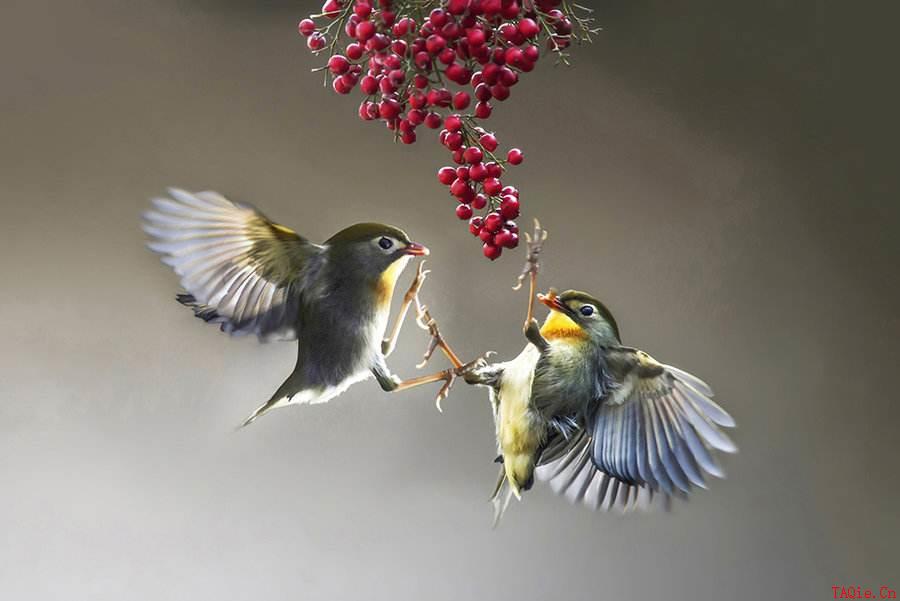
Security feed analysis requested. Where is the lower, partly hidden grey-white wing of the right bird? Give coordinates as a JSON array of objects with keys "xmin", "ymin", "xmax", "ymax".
[{"xmin": 535, "ymin": 430, "xmax": 653, "ymax": 512}]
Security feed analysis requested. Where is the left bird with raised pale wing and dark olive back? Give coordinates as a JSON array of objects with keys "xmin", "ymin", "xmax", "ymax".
[{"xmin": 143, "ymin": 189, "xmax": 446, "ymax": 425}]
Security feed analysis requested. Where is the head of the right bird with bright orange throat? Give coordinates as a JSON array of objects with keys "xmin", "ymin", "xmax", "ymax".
[{"xmin": 538, "ymin": 288, "xmax": 620, "ymax": 344}]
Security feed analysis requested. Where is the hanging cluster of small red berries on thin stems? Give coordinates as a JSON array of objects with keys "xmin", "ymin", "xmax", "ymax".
[{"xmin": 299, "ymin": 0, "xmax": 595, "ymax": 260}]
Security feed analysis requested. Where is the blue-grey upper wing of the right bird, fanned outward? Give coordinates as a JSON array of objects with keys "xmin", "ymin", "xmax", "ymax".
[{"xmin": 590, "ymin": 348, "xmax": 737, "ymax": 495}]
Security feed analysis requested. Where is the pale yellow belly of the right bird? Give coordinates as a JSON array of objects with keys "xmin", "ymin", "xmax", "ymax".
[{"xmin": 496, "ymin": 345, "xmax": 543, "ymax": 493}]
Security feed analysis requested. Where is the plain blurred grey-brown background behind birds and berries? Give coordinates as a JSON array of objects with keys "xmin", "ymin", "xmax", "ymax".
[{"xmin": 0, "ymin": 0, "xmax": 900, "ymax": 601}]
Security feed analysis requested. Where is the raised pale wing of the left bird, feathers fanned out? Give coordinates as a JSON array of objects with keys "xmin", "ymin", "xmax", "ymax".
[{"xmin": 143, "ymin": 189, "xmax": 324, "ymax": 340}]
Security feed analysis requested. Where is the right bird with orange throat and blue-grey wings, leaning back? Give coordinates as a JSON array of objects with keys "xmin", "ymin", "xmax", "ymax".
[{"xmin": 466, "ymin": 289, "xmax": 737, "ymax": 520}]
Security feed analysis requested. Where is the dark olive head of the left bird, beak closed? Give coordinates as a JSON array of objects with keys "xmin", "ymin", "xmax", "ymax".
[{"xmin": 325, "ymin": 223, "xmax": 428, "ymax": 301}]
